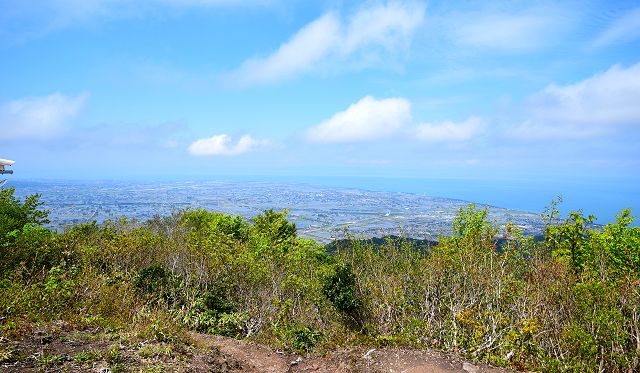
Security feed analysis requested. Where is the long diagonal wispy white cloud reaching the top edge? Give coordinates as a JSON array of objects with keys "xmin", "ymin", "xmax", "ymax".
[{"xmin": 227, "ymin": 1, "xmax": 424, "ymax": 85}]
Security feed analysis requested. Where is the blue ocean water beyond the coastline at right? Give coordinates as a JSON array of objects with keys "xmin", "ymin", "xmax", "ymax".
[{"xmin": 230, "ymin": 176, "xmax": 640, "ymax": 225}]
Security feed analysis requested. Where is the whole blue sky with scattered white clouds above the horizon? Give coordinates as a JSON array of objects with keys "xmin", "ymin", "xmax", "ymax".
[{"xmin": 0, "ymin": 0, "xmax": 640, "ymax": 215}]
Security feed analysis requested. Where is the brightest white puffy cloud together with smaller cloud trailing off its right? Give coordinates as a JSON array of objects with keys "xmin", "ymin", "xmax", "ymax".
[{"xmin": 307, "ymin": 96, "xmax": 485, "ymax": 143}]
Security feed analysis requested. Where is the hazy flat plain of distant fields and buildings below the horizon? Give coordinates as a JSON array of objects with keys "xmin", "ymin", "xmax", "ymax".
[{"xmin": 12, "ymin": 181, "xmax": 542, "ymax": 243}]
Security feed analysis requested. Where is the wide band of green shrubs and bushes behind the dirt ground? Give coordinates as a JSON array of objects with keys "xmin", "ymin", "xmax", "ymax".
[{"xmin": 0, "ymin": 195, "xmax": 640, "ymax": 372}]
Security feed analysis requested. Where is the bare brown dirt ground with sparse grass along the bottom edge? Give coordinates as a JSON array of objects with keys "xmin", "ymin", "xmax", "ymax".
[{"xmin": 0, "ymin": 324, "xmax": 511, "ymax": 373}]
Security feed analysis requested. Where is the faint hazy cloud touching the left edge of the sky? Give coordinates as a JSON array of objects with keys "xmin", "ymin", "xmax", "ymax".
[{"xmin": 0, "ymin": 93, "xmax": 88, "ymax": 140}]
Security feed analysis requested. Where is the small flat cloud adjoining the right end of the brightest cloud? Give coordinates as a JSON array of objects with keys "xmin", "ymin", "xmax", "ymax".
[{"xmin": 415, "ymin": 117, "xmax": 485, "ymax": 142}]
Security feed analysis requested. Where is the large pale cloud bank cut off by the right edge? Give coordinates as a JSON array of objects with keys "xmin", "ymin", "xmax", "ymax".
[{"xmin": 506, "ymin": 63, "xmax": 640, "ymax": 140}]
